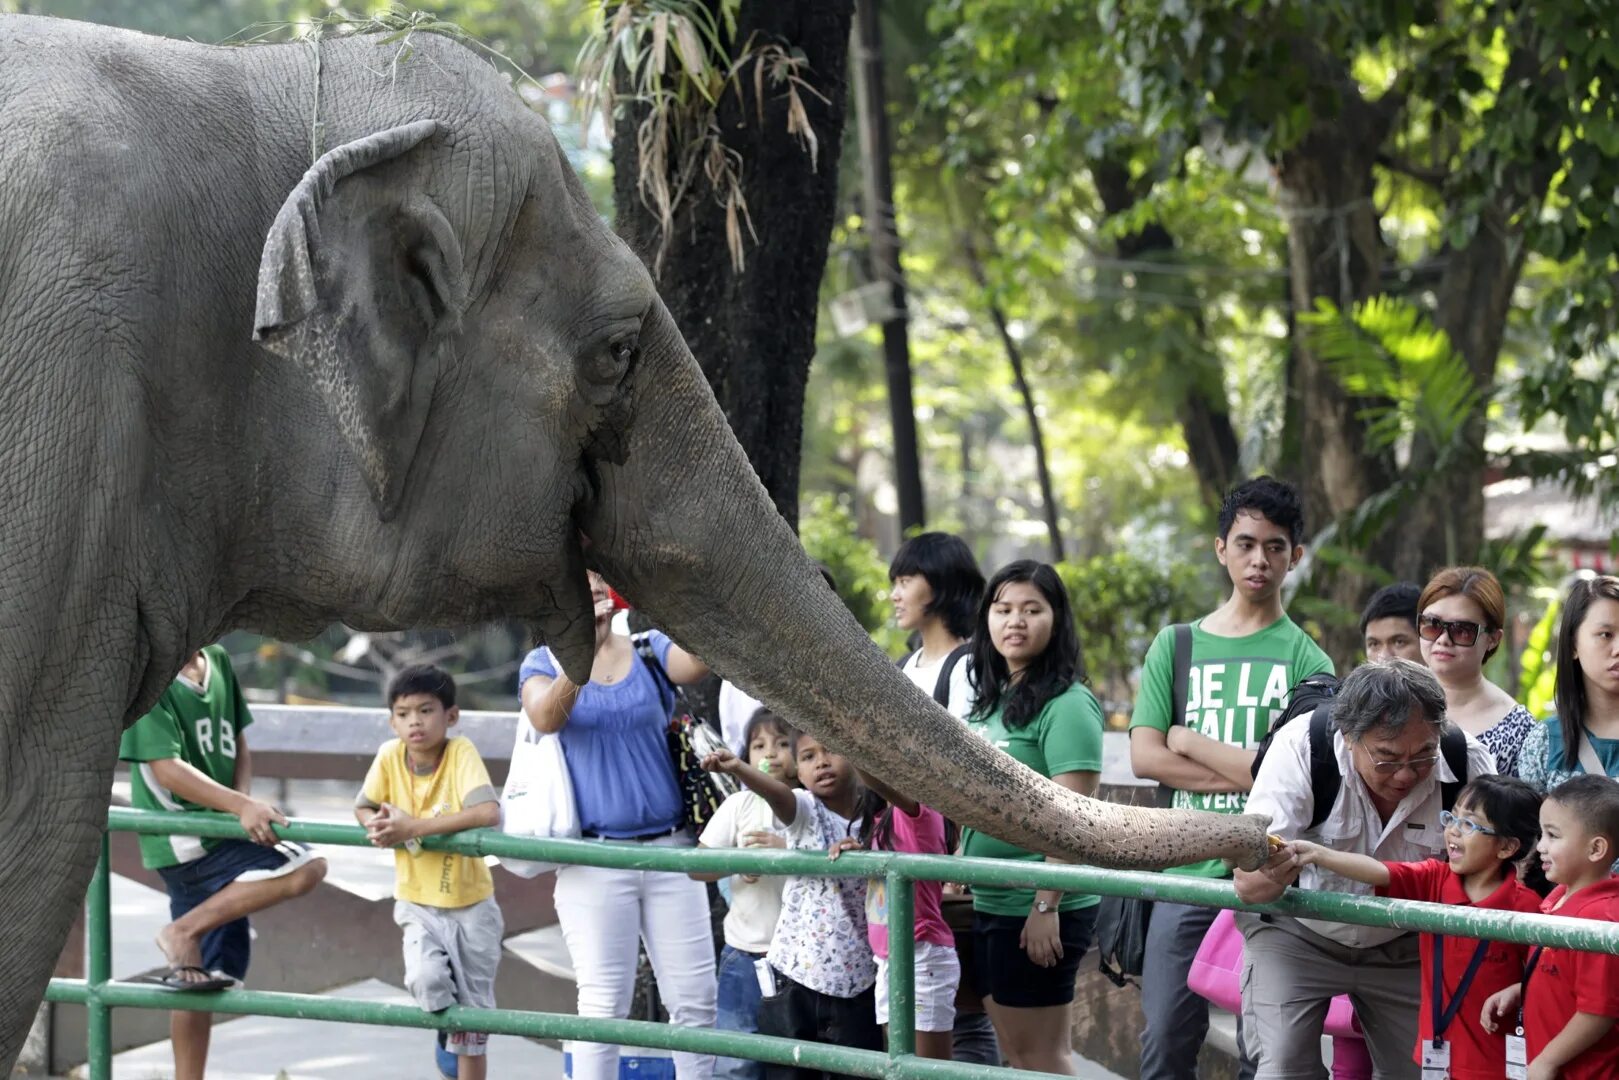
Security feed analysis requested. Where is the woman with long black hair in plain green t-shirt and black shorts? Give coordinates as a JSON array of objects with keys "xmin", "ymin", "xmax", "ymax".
[{"xmin": 962, "ymin": 560, "xmax": 1103, "ymax": 1075}]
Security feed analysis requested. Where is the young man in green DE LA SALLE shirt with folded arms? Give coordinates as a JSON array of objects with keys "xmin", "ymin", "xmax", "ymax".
[{"xmin": 1130, "ymin": 476, "xmax": 1332, "ymax": 1080}]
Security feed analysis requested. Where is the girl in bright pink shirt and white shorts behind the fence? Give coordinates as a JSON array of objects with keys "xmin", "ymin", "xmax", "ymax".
[{"xmin": 831, "ymin": 774, "xmax": 962, "ymax": 1061}]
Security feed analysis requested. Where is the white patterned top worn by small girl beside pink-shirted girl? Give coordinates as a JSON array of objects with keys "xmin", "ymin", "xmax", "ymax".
[{"xmin": 769, "ymin": 790, "xmax": 877, "ymax": 997}]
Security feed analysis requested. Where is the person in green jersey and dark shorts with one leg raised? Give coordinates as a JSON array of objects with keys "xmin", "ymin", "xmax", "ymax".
[{"xmin": 118, "ymin": 644, "xmax": 325, "ymax": 1080}]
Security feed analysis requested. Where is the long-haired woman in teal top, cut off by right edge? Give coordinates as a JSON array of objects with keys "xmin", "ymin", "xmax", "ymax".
[{"xmin": 1519, "ymin": 576, "xmax": 1619, "ymax": 792}]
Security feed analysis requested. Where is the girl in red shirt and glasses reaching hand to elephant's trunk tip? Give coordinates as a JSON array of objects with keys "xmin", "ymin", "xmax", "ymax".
[{"xmin": 1290, "ymin": 776, "xmax": 1546, "ymax": 1080}]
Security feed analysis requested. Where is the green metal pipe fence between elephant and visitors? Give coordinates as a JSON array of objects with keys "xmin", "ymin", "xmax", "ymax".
[{"xmin": 45, "ymin": 808, "xmax": 1619, "ymax": 1080}]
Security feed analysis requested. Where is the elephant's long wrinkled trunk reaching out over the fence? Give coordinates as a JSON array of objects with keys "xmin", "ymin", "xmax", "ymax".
[{"xmin": 576, "ymin": 304, "xmax": 1266, "ymax": 870}]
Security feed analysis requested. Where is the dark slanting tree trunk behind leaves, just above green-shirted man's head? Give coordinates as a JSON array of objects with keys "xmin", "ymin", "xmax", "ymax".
[{"xmin": 1091, "ymin": 160, "xmax": 1239, "ymax": 505}]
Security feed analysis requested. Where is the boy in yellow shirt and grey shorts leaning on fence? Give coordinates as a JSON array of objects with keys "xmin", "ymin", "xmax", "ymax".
[{"xmin": 355, "ymin": 664, "xmax": 505, "ymax": 1080}]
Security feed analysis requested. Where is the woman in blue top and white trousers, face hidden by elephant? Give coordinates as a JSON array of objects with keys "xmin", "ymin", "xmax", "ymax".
[{"xmin": 518, "ymin": 573, "xmax": 714, "ymax": 1080}]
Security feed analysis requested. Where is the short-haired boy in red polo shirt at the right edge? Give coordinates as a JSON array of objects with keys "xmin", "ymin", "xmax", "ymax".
[{"xmin": 1483, "ymin": 776, "xmax": 1619, "ymax": 1080}]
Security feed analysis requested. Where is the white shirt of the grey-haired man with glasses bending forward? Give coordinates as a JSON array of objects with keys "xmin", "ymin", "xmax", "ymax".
[{"xmin": 1247, "ymin": 716, "xmax": 1496, "ymax": 949}]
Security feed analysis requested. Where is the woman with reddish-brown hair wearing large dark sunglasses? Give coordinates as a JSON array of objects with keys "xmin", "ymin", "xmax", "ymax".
[{"xmin": 1417, "ymin": 567, "xmax": 1535, "ymax": 776}]
